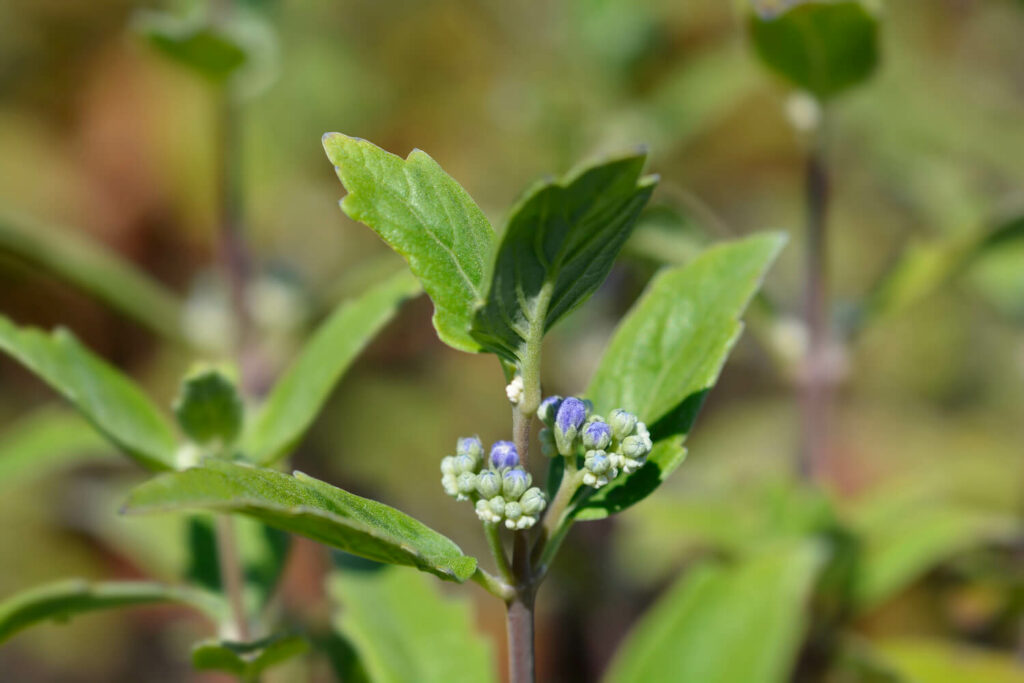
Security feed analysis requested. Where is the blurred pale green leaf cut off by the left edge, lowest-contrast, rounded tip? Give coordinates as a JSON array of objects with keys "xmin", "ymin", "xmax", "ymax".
[{"xmin": 0, "ymin": 407, "xmax": 115, "ymax": 490}]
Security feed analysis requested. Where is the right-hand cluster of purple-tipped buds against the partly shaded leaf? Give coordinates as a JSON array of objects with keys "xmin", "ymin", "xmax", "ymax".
[{"xmin": 538, "ymin": 396, "xmax": 653, "ymax": 488}]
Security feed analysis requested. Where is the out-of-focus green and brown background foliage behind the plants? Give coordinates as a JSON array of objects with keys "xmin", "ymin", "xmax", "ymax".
[{"xmin": 0, "ymin": 0, "xmax": 1024, "ymax": 682}]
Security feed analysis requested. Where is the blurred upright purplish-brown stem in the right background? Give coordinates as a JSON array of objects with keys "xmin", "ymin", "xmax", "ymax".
[{"xmin": 799, "ymin": 129, "xmax": 834, "ymax": 479}]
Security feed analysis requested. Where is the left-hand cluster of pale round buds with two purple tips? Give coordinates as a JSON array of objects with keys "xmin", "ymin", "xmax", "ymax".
[{"xmin": 441, "ymin": 436, "xmax": 548, "ymax": 529}]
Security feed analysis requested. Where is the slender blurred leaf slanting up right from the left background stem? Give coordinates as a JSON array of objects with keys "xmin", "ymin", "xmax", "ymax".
[{"xmin": 243, "ymin": 272, "xmax": 419, "ymax": 464}]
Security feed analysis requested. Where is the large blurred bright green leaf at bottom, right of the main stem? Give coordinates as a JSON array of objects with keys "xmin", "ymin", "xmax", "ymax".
[{"xmin": 605, "ymin": 541, "xmax": 824, "ymax": 683}]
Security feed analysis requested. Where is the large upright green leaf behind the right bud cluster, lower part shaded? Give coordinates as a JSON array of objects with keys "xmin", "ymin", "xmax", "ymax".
[{"xmin": 577, "ymin": 234, "xmax": 785, "ymax": 519}]
